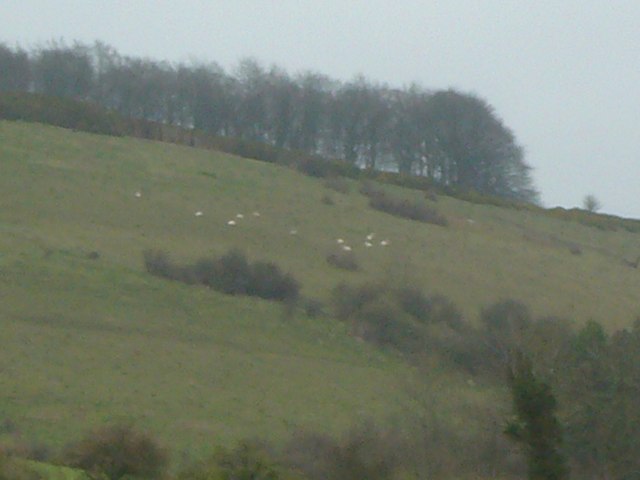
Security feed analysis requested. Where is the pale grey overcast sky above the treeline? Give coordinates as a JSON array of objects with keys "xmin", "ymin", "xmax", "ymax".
[{"xmin": 0, "ymin": 0, "xmax": 640, "ymax": 218}]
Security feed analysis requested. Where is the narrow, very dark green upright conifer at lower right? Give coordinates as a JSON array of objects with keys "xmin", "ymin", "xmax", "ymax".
[{"xmin": 505, "ymin": 351, "xmax": 569, "ymax": 480}]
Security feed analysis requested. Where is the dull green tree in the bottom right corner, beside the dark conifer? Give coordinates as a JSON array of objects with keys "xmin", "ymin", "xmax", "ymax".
[{"xmin": 558, "ymin": 321, "xmax": 640, "ymax": 480}]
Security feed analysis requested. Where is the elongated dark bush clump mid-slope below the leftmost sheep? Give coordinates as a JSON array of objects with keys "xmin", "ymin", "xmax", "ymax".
[{"xmin": 144, "ymin": 250, "xmax": 300, "ymax": 301}]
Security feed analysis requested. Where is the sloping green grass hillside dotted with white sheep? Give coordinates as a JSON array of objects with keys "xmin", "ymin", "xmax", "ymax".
[{"xmin": 0, "ymin": 122, "xmax": 640, "ymax": 458}]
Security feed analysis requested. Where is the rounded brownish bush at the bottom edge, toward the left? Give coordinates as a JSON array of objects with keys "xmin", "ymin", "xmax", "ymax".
[{"xmin": 65, "ymin": 425, "xmax": 168, "ymax": 480}]
